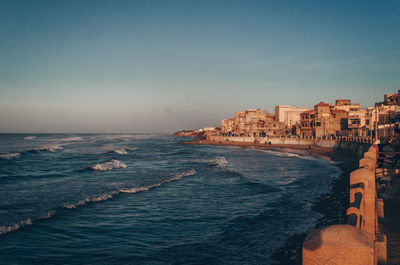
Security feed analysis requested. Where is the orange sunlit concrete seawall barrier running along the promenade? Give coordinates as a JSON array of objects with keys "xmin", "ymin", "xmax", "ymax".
[{"xmin": 303, "ymin": 147, "xmax": 388, "ymax": 265}]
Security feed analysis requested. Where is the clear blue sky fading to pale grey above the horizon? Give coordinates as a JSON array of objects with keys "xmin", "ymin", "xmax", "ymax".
[{"xmin": 0, "ymin": 0, "xmax": 400, "ymax": 133}]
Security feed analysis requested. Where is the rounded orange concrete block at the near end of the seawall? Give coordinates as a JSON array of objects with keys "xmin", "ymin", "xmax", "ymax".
[{"xmin": 303, "ymin": 225, "xmax": 375, "ymax": 265}]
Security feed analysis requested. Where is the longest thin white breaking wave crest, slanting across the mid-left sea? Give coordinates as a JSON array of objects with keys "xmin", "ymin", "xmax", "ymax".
[{"xmin": 62, "ymin": 169, "xmax": 196, "ymax": 209}]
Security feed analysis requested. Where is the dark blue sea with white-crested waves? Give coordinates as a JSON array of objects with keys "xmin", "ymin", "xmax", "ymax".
[{"xmin": 0, "ymin": 134, "xmax": 341, "ymax": 264}]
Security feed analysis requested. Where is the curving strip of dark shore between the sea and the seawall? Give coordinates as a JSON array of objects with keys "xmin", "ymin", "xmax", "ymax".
[{"xmin": 182, "ymin": 140, "xmax": 360, "ymax": 265}]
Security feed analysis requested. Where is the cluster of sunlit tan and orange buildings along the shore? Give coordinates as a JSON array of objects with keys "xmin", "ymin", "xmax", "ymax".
[{"xmin": 201, "ymin": 90, "xmax": 400, "ymax": 139}]
